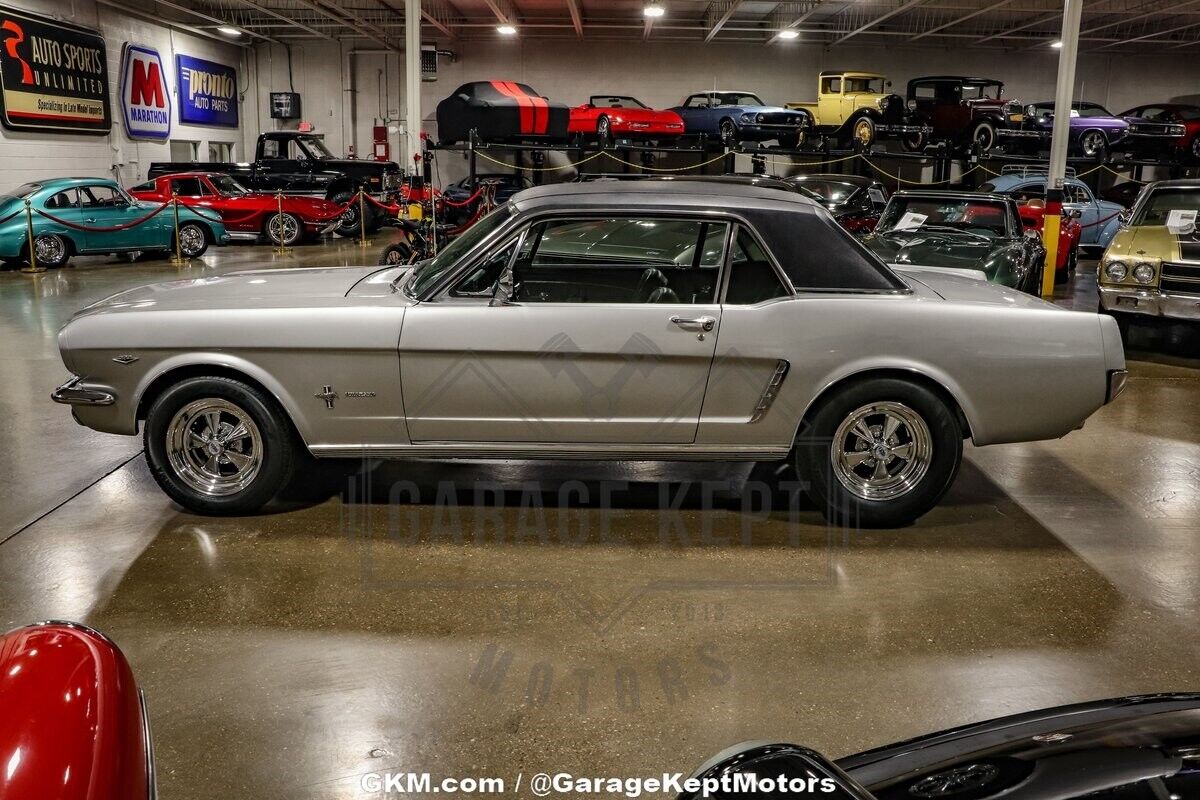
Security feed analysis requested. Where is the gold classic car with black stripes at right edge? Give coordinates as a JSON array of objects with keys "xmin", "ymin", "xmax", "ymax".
[{"xmin": 1099, "ymin": 178, "xmax": 1200, "ymax": 333}]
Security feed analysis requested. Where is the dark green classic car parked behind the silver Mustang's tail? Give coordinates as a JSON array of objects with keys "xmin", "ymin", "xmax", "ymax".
[{"xmin": 863, "ymin": 191, "xmax": 1046, "ymax": 295}]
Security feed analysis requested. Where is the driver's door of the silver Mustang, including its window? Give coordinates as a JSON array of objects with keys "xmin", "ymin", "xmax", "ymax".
[{"xmin": 400, "ymin": 216, "xmax": 728, "ymax": 444}]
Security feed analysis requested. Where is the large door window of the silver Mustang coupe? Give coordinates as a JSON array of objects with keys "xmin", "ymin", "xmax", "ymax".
[{"xmin": 512, "ymin": 217, "xmax": 728, "ymax": 305}]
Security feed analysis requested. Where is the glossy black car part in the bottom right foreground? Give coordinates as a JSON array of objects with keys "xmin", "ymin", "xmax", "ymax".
[{"xmin": 678, "ymin": 694, "xmax": 1200, "ymax": 800}]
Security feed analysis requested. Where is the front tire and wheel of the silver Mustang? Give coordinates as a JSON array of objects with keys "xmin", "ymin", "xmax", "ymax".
[{"xmin": 144, "ymin": 377, "xmax": 295, "ymax": 515}]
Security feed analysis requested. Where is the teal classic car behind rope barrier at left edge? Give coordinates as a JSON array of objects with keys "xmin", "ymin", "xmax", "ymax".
[{"xmin": 0, "ymin": 178, "xmax": 229, "ymax": 267}]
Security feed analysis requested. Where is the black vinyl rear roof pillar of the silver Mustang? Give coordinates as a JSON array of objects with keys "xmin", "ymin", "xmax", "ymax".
[{"xmin": 751, "ymin": 211, "xmax": 907, "ymax": 291}]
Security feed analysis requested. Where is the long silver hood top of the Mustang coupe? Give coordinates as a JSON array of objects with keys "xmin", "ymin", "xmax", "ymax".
[{"xmin": 76, "ymin": 266, "xmax": 380, "ymax": 318}]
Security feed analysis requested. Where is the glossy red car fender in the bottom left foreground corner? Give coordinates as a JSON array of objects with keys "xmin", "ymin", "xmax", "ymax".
[{"xmin": 0, "ymin": 622, "xmax": 155, "ymax": 800}]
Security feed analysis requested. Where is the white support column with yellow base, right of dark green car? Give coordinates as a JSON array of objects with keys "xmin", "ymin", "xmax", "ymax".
[{"xmin": 1042, "ymin": 0, "xmax": 1084, "ymax": 297}]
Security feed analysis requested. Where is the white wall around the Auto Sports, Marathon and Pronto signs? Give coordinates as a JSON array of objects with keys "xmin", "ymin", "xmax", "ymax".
[{"xmin": 0, "ymin": 0, "xmax": 246, "ymax": 190}]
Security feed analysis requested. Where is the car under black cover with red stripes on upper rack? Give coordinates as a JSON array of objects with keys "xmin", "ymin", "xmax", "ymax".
[{"xmin": 438, "ymin": 80, "xmax": 570, "ymax": 144}]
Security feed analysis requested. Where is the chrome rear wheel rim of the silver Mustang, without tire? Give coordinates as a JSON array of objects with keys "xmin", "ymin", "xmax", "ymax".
[{"xmin": 829, "ymin": 401, "xmax": 934, "ymax": 500}]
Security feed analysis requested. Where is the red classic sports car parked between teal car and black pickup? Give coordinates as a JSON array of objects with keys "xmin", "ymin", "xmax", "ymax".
[{"xmin": 130, "ymin": 173, "xmax": 338, "ymax": 246}]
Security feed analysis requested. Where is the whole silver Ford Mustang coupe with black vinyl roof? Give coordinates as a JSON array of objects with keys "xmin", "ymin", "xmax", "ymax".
[{"xmin": 53, "ymin": 182, "xmax": 1126, "ymax": 527}]
